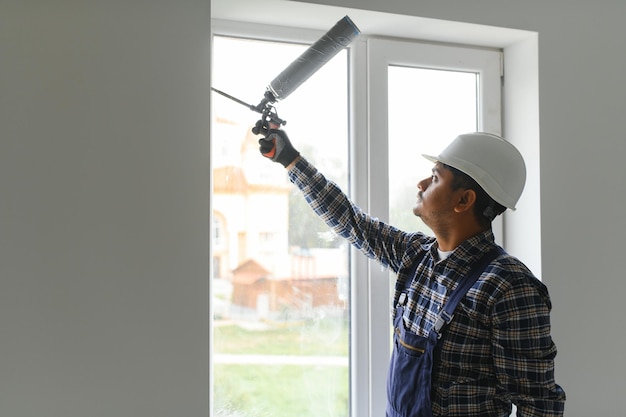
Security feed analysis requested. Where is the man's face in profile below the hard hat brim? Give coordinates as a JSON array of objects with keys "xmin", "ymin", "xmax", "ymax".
[{"xmin": 413, "ymin": 162, "xmax": 463, "ymax": 229}]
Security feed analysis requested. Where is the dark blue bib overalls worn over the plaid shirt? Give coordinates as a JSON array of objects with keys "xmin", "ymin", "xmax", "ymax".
[{"xmin": 386, "ymin": 247, "xmax": 501, "ymax": 417}]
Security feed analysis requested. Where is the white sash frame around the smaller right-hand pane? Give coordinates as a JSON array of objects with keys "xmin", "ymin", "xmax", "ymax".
[{"xmin": 360, "ymin": 37, "xmax": 502, "ymax": 416}]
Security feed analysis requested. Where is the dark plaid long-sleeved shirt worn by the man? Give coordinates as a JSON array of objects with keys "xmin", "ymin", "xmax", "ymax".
[{"xmin": 289, "ymin": 158, "xmax": 565, "ymax": 417}]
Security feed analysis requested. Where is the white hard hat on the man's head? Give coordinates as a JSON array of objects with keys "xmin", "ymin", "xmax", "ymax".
[{"xmin": 423, "ymin": 132, "xmax": 526, "ymax": 210}]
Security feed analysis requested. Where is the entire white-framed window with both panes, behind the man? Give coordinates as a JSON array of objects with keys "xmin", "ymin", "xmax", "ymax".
[{"xmin": 211, "ymin": 24, "xmax": 500, "ymax": 417}]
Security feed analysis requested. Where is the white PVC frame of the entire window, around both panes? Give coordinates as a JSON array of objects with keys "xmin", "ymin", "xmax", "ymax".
[{"xmin": 209, "ymin": 19, "xmax": 502, "ymax": 417}]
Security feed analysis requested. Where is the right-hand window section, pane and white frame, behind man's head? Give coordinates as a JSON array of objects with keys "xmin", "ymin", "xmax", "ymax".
[{"xmin": 353, "ymin": 39, "xmax": 501, "ymax": 415}]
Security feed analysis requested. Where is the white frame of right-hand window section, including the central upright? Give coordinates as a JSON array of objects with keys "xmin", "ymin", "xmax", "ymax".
[{"xmin": 351, "ymin": 38, "xmax": 502, "ymax": 417}]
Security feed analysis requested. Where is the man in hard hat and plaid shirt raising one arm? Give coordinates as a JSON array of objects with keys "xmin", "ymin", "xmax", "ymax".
[{"xmin": 257, "ymin": 125, "xmax": 565, "ymax": 417}]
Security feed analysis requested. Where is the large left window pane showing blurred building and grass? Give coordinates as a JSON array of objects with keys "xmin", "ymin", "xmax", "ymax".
[{"xmin": 211, "ymin": 36, "xmax": 350, "ymax": 417}]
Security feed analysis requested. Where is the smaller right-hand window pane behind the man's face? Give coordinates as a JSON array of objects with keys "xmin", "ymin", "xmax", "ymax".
[{"xmin": 389, "ymin": 66, "xmax": 478, "ymax": 234}]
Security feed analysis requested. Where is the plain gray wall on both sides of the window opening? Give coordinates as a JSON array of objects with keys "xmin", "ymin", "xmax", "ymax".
[{"xmin": 0, "ymin": 0, "xmax": 626, "ymax": 417}]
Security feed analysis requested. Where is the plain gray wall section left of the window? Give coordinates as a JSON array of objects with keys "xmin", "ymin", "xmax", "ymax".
[{"xmin": 0, "ymin": 0, "xmax": 210, "ymax": 417}]
